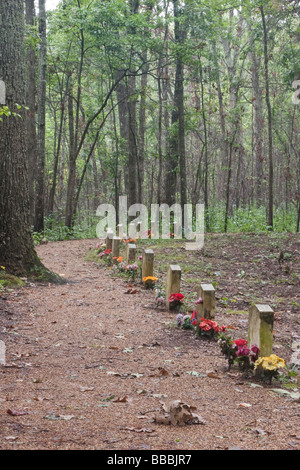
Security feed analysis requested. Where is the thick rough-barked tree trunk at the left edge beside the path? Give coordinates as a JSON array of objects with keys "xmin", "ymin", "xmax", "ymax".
[{"xmin": 0, "ymin": 0, "xmax": 55, "ymax": 275}]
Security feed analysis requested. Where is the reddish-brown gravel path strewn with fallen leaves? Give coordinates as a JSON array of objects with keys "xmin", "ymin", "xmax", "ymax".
[{"xmin": 0, "ymin": 240, "xmax": 300, "ymax": 450}]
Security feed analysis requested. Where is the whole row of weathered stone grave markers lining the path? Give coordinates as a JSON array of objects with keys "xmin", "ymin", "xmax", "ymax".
[{"xmin": 106, "ymin": 226, "xmax": 274, "ymax": 356}]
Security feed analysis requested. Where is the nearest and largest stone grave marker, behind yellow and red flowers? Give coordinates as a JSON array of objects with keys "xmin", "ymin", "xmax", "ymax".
[{"xmin": 248, "ymin": 304, "xmax": 274, "ymax": 357}]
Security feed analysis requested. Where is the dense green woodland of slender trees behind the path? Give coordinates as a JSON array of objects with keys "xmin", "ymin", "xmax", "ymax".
[{"xmin": 0, "ymin": 0, "xmax": 300, "ymax": 255}]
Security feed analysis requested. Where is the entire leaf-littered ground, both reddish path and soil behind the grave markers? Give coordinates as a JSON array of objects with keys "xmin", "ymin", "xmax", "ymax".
[{"xmin": 0, "ymin": 234, "xmax": 300, "ymax": 451}]
